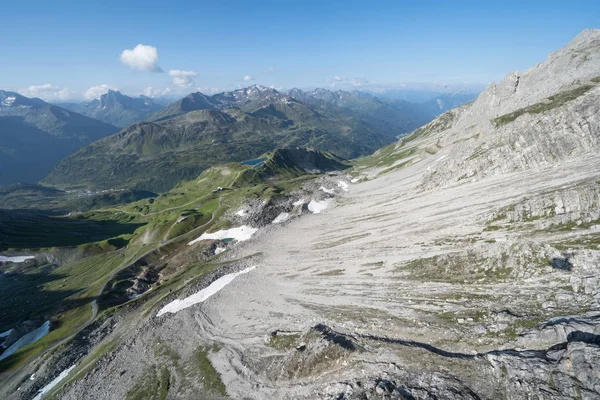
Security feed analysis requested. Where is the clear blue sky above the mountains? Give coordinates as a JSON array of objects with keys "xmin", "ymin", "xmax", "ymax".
[{"xmin": 0, "ymin": 0, "xmax": 600, "ymax": 100}]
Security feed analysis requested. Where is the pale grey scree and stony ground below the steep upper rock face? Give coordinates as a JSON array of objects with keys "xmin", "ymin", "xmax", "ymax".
[{"xmin": 45, "ymin": 148, "xmax": 600, "ymax": 399}]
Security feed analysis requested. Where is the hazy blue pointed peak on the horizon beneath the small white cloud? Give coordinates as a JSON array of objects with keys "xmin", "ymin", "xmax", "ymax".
[{"xmin": 59, "ymin": 90, "xmax": 164, "ymax": 128}]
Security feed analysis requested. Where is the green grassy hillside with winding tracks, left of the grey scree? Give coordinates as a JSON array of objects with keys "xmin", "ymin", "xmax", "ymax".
[{"xmin": 0, "ymin": 149, "xmax": 349, "ymax": 375}]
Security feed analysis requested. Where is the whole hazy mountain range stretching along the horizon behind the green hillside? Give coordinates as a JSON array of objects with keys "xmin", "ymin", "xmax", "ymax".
[{"xmin": 0, "ymin": 85, "xmax": 478, "ymax": 191}]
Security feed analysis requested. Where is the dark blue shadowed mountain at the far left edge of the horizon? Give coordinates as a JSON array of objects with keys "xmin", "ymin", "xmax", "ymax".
[{"xmin": 0, "ymin": 90, "xmax": 118, "ymax": 186}]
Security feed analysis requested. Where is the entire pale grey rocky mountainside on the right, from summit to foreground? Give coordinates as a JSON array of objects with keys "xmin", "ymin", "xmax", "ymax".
[{"xmin": 3, "ymin": 30, "xmax": 600, "ymax": 399}]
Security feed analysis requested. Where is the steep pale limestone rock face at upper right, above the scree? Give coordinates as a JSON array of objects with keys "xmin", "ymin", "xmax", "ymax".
[{"xmin": 386, "ymin": 29, "xmax": 600, "ymax": 189}]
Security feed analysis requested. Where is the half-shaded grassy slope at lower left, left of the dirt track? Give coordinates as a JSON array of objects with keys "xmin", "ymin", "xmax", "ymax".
[{"xmin": 0, "ymin": 247, "xmax": 149, "ymax": 371}]
